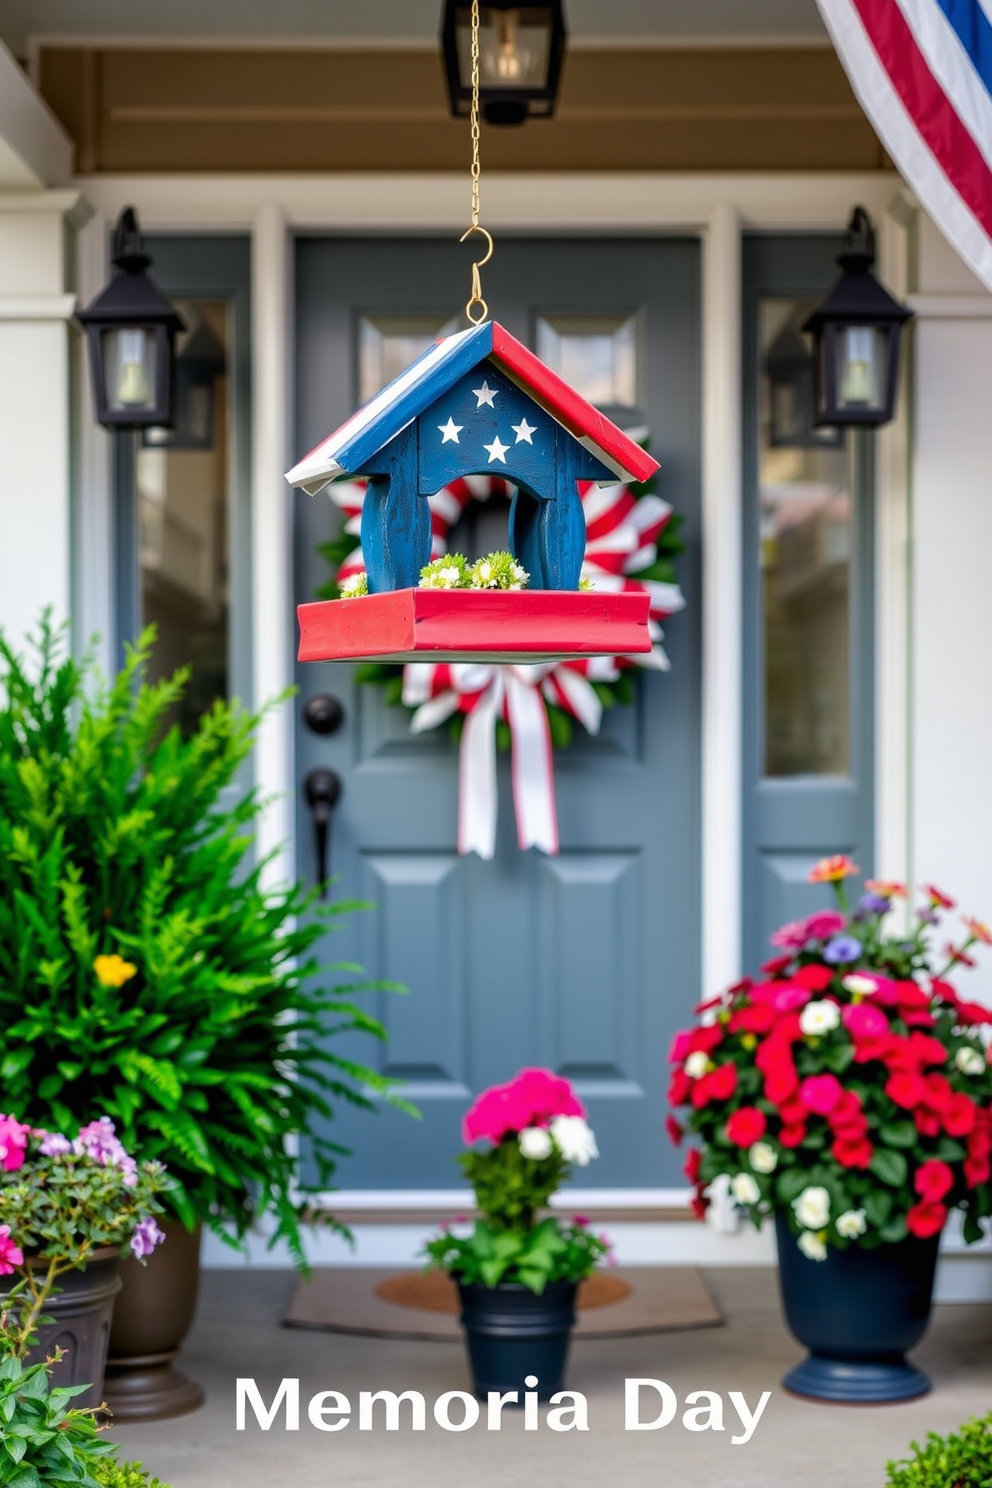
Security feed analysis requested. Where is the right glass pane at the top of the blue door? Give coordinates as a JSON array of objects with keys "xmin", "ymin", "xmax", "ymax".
[{"xmin": 535, "ymin": 315, "xmax": 640, "ymax": 408}]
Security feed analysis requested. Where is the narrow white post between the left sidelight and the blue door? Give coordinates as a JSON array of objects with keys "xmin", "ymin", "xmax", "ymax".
[{"xmin": 251, "ymin": 204, "xmax": 296, "ymax": 882}]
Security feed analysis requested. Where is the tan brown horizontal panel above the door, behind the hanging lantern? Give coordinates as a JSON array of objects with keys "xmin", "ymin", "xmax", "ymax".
[{"xmin": 37, "ymin": 45, "xmax": 889, "ymax": 176}]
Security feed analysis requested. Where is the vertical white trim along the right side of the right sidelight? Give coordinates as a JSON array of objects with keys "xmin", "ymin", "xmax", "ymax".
[{"xmin": 873, "ymin": 198, "xmax": 916, "ymax": 882}]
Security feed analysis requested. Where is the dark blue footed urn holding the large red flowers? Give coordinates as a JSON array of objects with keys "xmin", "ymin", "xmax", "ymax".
[{"xmin": 775, "ymin": 1214, "xmax": 940, "ymax": 1405}]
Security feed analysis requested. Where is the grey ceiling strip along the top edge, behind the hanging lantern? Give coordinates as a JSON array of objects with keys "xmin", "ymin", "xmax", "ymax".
[{"xmin": 0, "ymin": 0, "xmax": 825, "ymax": 57}]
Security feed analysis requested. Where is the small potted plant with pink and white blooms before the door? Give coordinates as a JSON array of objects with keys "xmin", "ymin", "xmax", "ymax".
[{"xmin": 425, "ymin": 1068, "xmax": 610, "ymax": 1400}]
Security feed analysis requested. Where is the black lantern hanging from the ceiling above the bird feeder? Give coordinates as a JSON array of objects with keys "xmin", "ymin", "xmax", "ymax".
[{"xmin": 440, "ymin": 0, "xmax": 565, "ymax": 124}]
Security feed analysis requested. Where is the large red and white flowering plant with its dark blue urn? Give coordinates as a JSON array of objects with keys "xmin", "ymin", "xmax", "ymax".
[{"xmin": 669, "ymin": 857, "xmax": 992, "ymax": 1402}]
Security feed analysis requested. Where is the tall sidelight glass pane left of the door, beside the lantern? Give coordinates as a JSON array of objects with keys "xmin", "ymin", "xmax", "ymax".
[{"xmin": 137, "ymin": 301, "xmax": 231, "ymax": 729}]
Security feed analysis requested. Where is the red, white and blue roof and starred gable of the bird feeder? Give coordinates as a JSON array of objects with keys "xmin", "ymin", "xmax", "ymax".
[{"xmin": 287, "ymin": 321, "xmax": 657, "ymax": 496}]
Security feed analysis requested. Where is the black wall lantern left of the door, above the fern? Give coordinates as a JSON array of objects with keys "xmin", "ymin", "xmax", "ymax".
[{"xmin": 76, "ymin": 207, "xmax": 184, "ymax": 429}]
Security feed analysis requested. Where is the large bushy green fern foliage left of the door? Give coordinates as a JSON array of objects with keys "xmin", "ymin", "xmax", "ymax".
[{"xmin": 0, "ymin": 618, "xmax": 409, "ymax": 1269}]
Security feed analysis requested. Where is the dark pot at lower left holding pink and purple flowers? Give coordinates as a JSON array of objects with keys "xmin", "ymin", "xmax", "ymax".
[{"xmin": 0, "ymin": 1245, "xmax": 120, "ymax": 1409}]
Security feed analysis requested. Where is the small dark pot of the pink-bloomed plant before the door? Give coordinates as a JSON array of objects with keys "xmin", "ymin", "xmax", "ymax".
[{"xmin": 458, "ymin": 1281, "xmax": 576, "ymax": 1405}]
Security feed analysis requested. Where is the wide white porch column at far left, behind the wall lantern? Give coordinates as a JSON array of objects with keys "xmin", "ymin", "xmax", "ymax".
[{"xmin": 0, "ymin": 190, "xmax": 85, "ymax": 647}]
